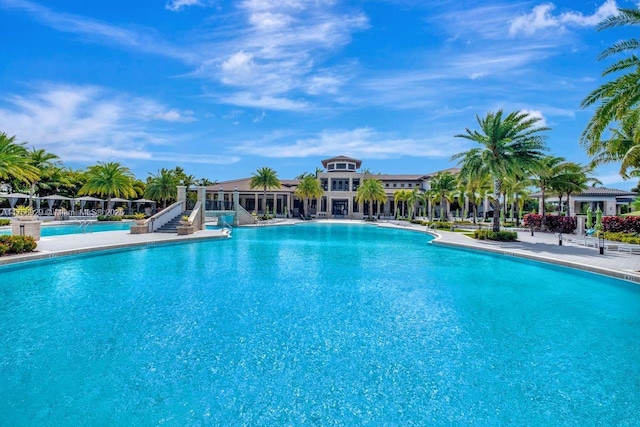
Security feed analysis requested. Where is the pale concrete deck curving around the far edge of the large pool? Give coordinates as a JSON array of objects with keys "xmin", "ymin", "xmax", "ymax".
[{"xmin": 0, "ymin": 220, "xmax": 640, "ymax": 283}]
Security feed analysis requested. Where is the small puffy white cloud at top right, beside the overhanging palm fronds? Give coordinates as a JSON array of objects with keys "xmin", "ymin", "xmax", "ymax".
[{"xmin": 509, "ymin": 0, "xmax": 618, "ymax": 36}]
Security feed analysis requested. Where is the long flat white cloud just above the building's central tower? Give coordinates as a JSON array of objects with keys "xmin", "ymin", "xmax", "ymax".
[{"xmin": 235, "ymin": 128, "xmax": 461, "ymax": 159}]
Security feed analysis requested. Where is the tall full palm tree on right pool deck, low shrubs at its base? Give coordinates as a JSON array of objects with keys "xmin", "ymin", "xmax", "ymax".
[{"xmin": 451, "ymin": 110, "xmax": 549, "ymax": 232}]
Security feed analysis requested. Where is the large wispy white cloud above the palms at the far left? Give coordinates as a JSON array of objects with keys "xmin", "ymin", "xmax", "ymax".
[{"xmin": 0, "ymin": 85, "xmax": 194, "ymax": 161}]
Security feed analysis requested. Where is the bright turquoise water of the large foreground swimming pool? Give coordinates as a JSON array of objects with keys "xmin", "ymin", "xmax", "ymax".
[{"xmin": 0, "ymin": 224, "xmax": 640, "ymax": 426}]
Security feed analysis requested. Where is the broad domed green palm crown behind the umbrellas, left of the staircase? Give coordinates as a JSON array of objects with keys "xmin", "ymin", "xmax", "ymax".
[{"xmin": 78, "ymin": 162, "xmax": 136, "ymax": 205}]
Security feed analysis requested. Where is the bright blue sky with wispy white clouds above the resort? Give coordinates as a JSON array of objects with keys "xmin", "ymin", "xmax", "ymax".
[{"xmin": 0, "ymin": 0, "xmax": 638, "ymax": 189}]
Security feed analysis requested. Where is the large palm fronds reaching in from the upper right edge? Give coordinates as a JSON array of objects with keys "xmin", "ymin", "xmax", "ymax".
[{"xmin": 580, "ymin": 8, "xmax": 640, "ymax": 155}]
